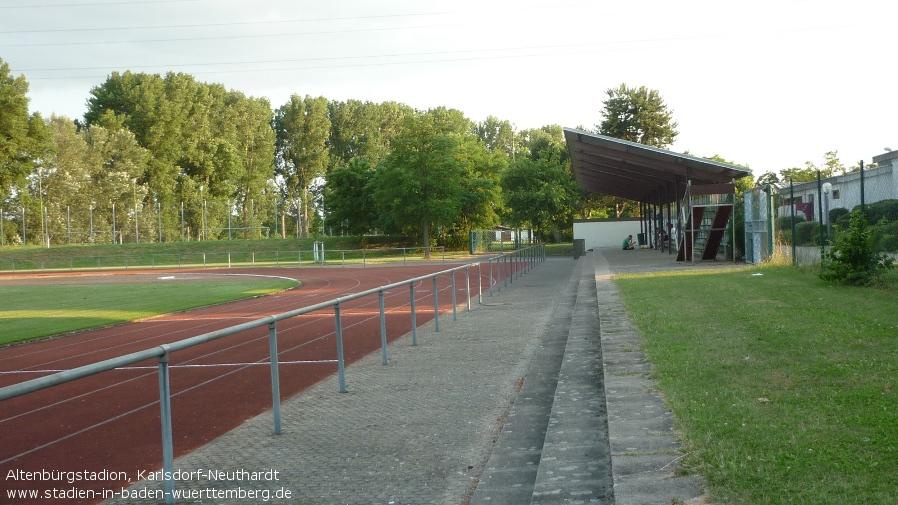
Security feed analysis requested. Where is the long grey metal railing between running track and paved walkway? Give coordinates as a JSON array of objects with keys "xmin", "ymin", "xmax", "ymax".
[{"xmin": 0, "ymin": 244, "xmax": 546, "ymax": 504}]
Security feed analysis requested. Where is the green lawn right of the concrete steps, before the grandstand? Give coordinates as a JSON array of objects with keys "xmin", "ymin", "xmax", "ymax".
[{"xmin": 616, "ymin": 267, "xmax": 898, "ymax": 505}]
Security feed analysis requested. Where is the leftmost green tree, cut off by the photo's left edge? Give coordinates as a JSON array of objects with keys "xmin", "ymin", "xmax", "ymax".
[{"xmin": 0, "ymin": 59, "xmax": 50, "ymax": 201}]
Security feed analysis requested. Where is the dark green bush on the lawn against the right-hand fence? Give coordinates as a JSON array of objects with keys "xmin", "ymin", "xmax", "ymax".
[{"xmin": 820, "ymin": 210, "xmax": 893, "ymax": 285}]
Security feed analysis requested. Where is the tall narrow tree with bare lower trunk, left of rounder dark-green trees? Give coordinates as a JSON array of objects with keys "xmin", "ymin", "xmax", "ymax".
[{"xmin": 272, "ymin": 95, "xmax": 331, "ymax": 237}]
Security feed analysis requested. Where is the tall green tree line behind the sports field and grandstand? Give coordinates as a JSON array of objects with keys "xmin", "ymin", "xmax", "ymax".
[{"xmin": 0, "ymin": 60, "xmax": 688, "ymax": 246}]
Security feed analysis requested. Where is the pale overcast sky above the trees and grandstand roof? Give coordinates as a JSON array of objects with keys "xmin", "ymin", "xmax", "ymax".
[{"xmin": 0, "ymin": 0, "xmax": 898, "ymax": 178}]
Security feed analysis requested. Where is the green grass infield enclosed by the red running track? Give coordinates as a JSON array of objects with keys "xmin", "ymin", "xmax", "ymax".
[{"xmin": 0, "ymin": 278, "xmax": 296, "ymax": 345}]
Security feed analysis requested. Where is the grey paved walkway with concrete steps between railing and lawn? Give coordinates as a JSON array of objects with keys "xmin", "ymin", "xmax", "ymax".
[{"xmin": 107, "ymin": 250, "xmax": 700, "ymax": 505}]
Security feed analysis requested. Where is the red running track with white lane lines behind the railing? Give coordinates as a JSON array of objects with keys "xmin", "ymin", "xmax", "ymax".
[{"xmin": 0, "ymin": 265, "xmax": 500, "ymax": 504}]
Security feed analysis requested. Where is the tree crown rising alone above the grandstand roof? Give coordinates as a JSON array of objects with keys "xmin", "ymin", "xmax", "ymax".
[{"xmin": 596, "ymin": 84, "xmax": 679, "ymax": 149}]
